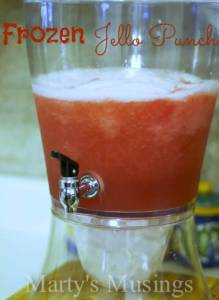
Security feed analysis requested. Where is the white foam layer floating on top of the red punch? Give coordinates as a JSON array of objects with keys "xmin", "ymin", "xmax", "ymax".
[{"xmin": 33, "ymin": 68, "xmax": 219, "ymax": 101}]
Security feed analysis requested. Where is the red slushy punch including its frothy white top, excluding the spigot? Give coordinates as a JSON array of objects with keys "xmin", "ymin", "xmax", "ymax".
[{"xmin": 34, "ymin": 70, "xmax": 218, "ymax": 212}]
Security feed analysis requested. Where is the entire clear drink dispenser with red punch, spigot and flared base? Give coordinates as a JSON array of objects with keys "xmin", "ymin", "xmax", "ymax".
[{"xmin": 25, "ymin": 0, "xmax": 219, "ymax": 300}]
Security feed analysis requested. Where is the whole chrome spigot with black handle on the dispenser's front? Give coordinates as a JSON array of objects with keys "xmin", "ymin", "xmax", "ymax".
[{"xmin": 51, "ymin": 151, "xmax": 100, "ymax": 213}]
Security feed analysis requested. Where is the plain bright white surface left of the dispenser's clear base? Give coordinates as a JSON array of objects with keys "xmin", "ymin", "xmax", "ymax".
[{"xmin": 0, "ymin": 176, "xmax": 51, "ymax": 300}]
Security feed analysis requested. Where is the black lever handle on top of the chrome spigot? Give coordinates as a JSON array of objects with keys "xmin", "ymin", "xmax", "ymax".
[{"xmin": 51, "ymin": 150, "xmax": 79, "ymax": 177}]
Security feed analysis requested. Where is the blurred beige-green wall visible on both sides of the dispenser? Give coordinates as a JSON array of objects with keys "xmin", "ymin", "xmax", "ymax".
[{"xmin": 0, "ymin": 0, "xmax": 219, "ymax": 190}]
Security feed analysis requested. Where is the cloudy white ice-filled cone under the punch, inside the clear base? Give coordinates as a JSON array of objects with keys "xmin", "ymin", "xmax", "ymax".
[{"xmin": 73, "ymin": 221, "xmax": 170, "ymax": 290}]
